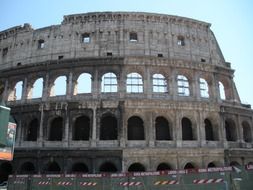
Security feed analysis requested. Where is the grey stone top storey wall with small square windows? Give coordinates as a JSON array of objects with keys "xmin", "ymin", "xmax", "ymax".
[{"xmin": 0, "ymin": 12, "xmax": 227, "ymax": 69}]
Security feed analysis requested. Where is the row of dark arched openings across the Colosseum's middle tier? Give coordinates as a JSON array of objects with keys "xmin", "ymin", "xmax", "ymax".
[{"xmin": 24, "ymin": 114, "xmax": 252, "ymax": 142}]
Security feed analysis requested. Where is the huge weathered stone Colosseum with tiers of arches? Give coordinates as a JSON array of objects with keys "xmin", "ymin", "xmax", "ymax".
[{"xmin": 0, "ymin": 12, "xmax": 253, "ymax": 181}]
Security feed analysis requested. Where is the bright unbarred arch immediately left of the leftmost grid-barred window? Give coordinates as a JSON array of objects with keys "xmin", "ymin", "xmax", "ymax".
[{"xmin": 77, "ymin": 73, "xmax": 91, "ymax": 94}]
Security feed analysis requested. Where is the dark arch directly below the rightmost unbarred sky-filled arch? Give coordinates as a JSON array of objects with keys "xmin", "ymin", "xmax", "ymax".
[{"xmin": 72, "ymin": 116, "xmax": 90, "ymax": 141}]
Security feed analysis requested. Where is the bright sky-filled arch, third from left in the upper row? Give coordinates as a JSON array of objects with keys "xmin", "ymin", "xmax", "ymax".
[{"xmin": 50, "ymin": 76, "xmax": 67, "ymax": 96}]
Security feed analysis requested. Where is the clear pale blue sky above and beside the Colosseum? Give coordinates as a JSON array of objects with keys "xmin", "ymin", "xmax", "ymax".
[{"xmin": 0, "ymin": 0, "xmax": 253, "ymax": 106}]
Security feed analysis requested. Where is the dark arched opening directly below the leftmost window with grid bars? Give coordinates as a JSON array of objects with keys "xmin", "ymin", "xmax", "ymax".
[{"xmin": 100, "ymin": 116, "xmax": 118, "ymax": 140}]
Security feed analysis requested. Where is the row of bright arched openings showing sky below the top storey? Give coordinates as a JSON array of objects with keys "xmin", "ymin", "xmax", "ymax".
[{"xmin": 8, "ymin": 72, "xmax": 228, "ymax": 101}]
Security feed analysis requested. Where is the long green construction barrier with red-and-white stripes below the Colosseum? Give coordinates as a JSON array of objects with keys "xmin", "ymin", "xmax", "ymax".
[{"xmin": 8, "ymin": 165, "xmax": 253, "ymax": 190}]
